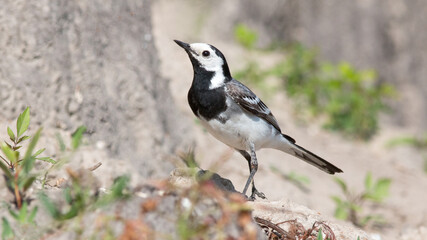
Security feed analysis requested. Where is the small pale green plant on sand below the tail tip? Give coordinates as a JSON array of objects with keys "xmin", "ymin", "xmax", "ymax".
[{"xmin": 332, "ymin": 173, "xmax": 391, "ymax": 227}]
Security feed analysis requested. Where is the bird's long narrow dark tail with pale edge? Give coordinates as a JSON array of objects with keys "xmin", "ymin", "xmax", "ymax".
[{"xmin": 280, "ymin": 135, "xmax": 343, "ymax": 174}]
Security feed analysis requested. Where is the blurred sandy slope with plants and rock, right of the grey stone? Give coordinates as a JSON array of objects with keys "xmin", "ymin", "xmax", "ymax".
[{"xmin": 153, "ymin": 0, "xmax": 427, "ymax": 238}]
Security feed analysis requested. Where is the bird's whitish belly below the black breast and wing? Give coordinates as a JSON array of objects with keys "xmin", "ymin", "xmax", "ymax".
[{"xmin": 201, "ymin": 99, "xmax": 280, "ymax": 151}]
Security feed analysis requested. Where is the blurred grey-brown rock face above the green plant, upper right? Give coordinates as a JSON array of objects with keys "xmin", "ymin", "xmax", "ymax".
[{"xmin": 239, "ymin": 0, "xmax": 427, "ymax": 131}]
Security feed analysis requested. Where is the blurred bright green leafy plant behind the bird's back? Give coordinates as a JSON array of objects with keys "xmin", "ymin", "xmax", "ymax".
[{"xmin": 237, "ymin": 44, "xmax": 395, "ymax": 140}]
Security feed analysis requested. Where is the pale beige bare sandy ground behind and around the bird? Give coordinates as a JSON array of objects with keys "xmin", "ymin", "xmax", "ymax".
[{"xmin": 153, "ymin": 0, "xmax": 427, "ymax": 239}]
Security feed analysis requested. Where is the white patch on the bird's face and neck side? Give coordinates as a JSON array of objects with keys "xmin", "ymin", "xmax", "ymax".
[{"xmin": 190, "ymin": 43, "xmax": 225, "ymax": 89}]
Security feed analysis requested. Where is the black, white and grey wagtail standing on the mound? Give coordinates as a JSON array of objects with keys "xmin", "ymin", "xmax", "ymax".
[{"xmin": 174, "ymin": 40, "xmax": 343, "ymax": 200}]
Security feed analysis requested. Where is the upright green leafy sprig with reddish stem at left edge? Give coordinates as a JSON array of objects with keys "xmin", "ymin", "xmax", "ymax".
[{"xmin": 0, "ymin": 107, "xmax": 56, "ymax": 239}]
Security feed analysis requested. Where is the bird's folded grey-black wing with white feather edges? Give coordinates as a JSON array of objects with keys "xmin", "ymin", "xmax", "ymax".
[{"xmin": 225, "ymin": 79, "xmax": 281, "ymax": 132}]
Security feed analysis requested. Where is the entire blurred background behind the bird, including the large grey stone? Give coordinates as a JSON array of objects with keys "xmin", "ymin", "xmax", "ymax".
[{"xmin": 0, "ymin": 0, "xmax": 427, "ymax": 239}]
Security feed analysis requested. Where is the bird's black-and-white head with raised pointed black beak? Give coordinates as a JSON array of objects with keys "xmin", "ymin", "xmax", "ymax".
[{"xmin": 174, "ymin": 40, "xmax": 231, "ymax": 78}]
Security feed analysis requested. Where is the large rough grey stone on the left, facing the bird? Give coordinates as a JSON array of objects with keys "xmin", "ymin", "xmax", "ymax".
[{"xmin": 0, "ymin": 0, "xmax": 186, "ymax": 178}]
